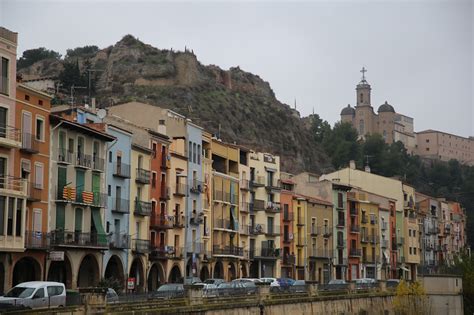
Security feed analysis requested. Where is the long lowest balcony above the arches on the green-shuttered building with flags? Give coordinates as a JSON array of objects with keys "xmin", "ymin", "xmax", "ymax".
[{"xmin": 50, "ymin": 230, "xmax": 108, "ymax": 249}]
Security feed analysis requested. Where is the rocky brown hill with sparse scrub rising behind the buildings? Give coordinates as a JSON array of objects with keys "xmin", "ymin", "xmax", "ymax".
[{"xmin": 19, "ymin": 35, "xmax": 330, "ymax": 172}]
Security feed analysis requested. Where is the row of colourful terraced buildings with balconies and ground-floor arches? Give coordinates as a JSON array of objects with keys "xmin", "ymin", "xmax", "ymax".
[{"xmin": 0, "ymin": 28, "xmax": 465, "ymax": 292}]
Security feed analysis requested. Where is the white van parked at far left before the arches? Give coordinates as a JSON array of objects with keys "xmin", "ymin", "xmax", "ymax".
[{"xmin": 0, "ymin": 281, "xmax": 66, "ymax": 309}]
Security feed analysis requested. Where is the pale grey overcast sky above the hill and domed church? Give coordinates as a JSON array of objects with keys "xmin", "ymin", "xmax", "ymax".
[{"xmin": 0, "ymin": 0, "xmax": 474, "ymax": 136}]
